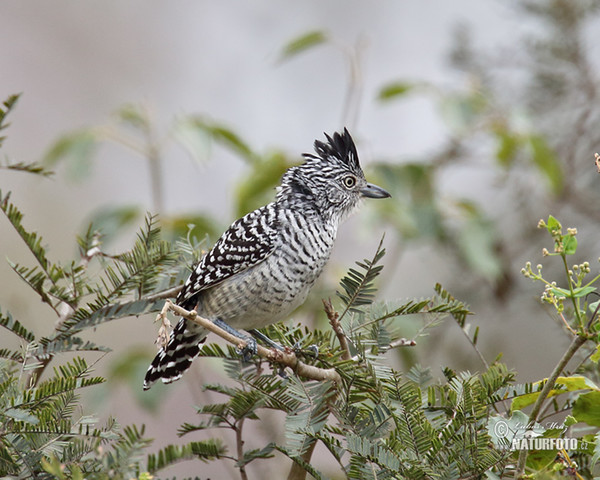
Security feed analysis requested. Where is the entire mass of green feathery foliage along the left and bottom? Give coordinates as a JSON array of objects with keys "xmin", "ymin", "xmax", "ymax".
[{"xmin": 0, "ymin": 92, "xmax": 572, "ymax": 480}]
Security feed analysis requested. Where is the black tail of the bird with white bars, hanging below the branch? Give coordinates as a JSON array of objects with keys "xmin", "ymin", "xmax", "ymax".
[{"xmin": 144, "ymin": 318, "xmax": 206, "ymax": 390}]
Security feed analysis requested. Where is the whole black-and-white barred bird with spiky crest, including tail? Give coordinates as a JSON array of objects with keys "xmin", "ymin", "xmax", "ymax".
[{"xmin": 144, "ymin": 129, "xmax": 390, "ymax": 390}]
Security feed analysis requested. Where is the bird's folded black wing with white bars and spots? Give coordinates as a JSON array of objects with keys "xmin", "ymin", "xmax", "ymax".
[{"xmin": 176, "ymin": 204, "xmax": 277, "ymax": 309}]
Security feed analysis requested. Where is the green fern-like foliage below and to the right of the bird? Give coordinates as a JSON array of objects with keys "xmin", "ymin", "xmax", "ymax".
[{"xmin": 180, "ymin": 268, "xmax": 513, "ymax": 479}]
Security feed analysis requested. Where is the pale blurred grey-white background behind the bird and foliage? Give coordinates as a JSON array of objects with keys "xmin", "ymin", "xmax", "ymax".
[{"xmin": 0, "ymin": 0, "xmax": 560, "ymax": 478}]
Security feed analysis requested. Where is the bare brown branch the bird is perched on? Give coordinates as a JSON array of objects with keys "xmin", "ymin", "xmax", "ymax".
[{"xmin": 166, "ymin": 300, "xmax": 342, "ymax": 385}]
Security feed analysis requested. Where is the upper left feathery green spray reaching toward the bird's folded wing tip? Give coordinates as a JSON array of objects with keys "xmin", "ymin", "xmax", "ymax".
[{"xmin": 0, "ymin": 192, "xmax": 180, "ymax": 357}]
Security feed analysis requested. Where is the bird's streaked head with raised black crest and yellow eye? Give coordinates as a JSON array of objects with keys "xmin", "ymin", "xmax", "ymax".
[{"xmin": 277, "ymin": 129, "xmax": 390, "ymax": 223}]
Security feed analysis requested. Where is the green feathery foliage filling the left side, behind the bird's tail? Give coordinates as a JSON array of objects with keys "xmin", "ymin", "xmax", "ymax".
[{"xmin": 0, "ymin": 96, "xmax": 230, "ymax": 480}]
